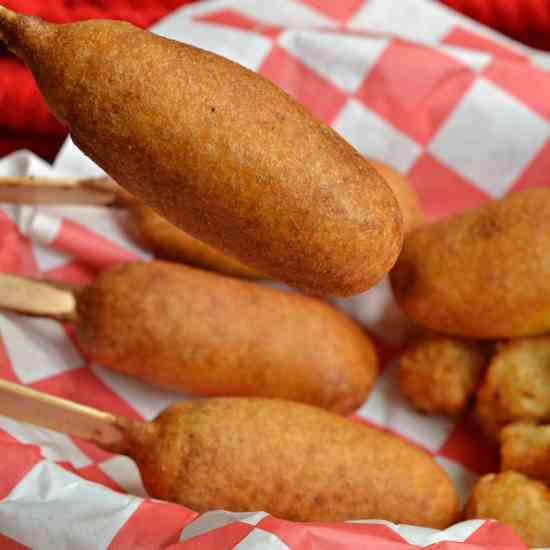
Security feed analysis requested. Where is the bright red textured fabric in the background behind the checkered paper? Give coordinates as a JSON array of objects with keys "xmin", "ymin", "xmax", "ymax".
[{"xmin": 0, "ymin": 0, "xmax": 550, "ymax": 164}]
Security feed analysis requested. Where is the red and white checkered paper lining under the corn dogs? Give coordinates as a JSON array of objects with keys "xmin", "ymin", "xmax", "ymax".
[{"xmin": 0, "ymin": 0, "xmax": 550, "ymax": 550}]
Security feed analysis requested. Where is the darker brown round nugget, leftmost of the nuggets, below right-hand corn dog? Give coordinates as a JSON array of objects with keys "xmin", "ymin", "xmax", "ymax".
[{"xmin": 399, "ymin": 336, "xmax": 488, "ymax": 416}]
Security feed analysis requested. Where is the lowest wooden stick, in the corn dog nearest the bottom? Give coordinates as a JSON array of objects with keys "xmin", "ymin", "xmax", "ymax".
[{"xmin": 0, "ymin": 379, "xmax": 127, "ymax": 448}]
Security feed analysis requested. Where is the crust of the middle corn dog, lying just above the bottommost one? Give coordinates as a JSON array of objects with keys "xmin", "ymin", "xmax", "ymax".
[{"xmin": 77, "ymin": 262, "xmax": 377, "ymax": 413}]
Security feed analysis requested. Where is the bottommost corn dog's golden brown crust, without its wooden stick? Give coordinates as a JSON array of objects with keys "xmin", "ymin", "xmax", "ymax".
[{"xmin": 129, "ymin": 398, "xmax": 458, "ymax": 528}]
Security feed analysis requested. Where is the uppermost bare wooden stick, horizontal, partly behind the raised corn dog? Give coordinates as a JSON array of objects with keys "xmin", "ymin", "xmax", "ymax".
[{"xmin": 0, "ymin": 176, "xmax": 122, "ymax": 206}]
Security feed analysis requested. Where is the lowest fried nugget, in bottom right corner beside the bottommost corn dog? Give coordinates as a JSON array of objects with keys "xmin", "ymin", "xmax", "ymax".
[{"xmin": 465, "ymin": 471, "xmax": 550, "ymax": 547}]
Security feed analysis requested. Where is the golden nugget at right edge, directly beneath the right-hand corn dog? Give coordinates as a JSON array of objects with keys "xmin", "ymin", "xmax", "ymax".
[{"xmin": 476, "ymin": 336, "xmax": 550, "ymax": 440}]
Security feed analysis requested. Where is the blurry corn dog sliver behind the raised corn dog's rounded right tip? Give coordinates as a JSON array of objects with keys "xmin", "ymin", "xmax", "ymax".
[{"xmin": 369, "ymin": 159, "xmax": 426, "ymax": 234}]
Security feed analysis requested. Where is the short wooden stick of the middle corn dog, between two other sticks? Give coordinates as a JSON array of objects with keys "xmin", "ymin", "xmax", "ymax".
[{"xmin": 0, "ymin": 273, "xmax": 77, "ymax": 321}]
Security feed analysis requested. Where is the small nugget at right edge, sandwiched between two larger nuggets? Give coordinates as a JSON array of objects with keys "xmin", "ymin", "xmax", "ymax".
[{"xmin": 500, "ymin": 422, "xmax": 550, "ymax": 485}]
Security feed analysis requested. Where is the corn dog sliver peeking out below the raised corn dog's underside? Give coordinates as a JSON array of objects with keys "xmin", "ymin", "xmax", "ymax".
[{"xmin": 128, "ymin": 201, "xmax": 262, "ymax": 279}]
